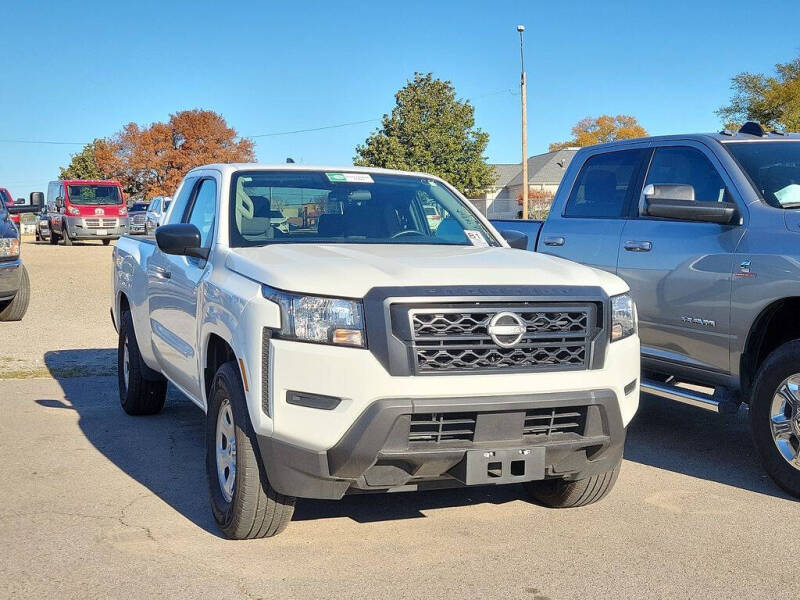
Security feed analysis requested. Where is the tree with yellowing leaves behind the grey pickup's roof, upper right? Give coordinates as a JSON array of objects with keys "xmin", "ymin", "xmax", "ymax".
[{"xmin": 717, "ymin": 57, "xmax": 800, "ymax": 132}]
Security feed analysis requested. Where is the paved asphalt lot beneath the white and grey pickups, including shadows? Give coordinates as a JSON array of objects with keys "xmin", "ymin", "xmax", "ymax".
[{"xmin": 0, "ymin": 377, "xmax": 800, "ymax": 600}]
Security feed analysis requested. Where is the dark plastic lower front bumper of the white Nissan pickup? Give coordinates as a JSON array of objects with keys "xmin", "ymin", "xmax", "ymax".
[{"xmin": 258, "ymin": 390, "xmax": 625, "ymax": 499}]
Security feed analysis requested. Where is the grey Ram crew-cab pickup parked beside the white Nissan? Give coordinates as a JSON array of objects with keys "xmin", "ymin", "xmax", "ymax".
[{"xmin": 490, "ymin": 123, "xmax": 800, "ymax": 496}]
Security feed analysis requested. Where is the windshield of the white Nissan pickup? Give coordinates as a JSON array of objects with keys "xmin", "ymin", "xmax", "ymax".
[{"xmin": 230, "ymin": 171, "xmax": 500, "ymax": 247}]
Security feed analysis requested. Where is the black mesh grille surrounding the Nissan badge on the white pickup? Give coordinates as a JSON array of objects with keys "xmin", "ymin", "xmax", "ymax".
[{"xmin": 409, "ymin": 303, "xmax": 596, "ymax": 373}]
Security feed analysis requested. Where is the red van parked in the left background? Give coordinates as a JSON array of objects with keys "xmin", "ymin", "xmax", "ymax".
[{"xmin": 47, "ymin": 179, "xmax": 129, "ymax": 246}]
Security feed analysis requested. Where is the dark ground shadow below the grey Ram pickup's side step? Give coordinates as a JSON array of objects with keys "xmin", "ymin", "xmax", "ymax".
[{"xmin": 625, "ymin": 395, "xmax": 793, "ymax": 500}]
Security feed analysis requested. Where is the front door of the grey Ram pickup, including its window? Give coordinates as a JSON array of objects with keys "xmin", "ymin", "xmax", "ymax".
[{"xmin": 617, "ymin": 141, "xmax": 745, "ymax": 374}]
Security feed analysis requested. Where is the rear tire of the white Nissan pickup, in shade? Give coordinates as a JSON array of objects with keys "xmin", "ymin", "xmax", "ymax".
[{"xmin": 117, "ymin": 311, "xmax": 167, "ymax": 416}]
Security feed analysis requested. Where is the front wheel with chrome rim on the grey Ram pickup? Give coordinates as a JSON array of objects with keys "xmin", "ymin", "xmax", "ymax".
[{"xmin": 750, "ymin": 340, "xmax": 800, "ymax": 497}]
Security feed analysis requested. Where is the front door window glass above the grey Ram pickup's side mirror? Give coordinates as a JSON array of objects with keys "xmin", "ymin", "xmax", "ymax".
[{"xmin": 645, "ymin": 146, "xmax": 728, "ymax": 202}]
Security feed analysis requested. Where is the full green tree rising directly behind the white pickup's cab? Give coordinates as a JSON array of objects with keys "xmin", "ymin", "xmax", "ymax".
[{"xmin": 353, "ymin": 73, "xmax": 496, "ymax": 197}]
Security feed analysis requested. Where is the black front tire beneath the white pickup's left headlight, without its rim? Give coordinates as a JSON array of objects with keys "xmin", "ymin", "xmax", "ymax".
[{"xmin": 206, "ymin": 361, "xmax": 295, "ymax": 540}]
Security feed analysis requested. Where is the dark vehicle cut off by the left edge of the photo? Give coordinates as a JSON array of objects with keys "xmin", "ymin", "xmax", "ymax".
[{"xmin": 0, "ymin": 201, "xmax": 31, "ymax": 321}]
